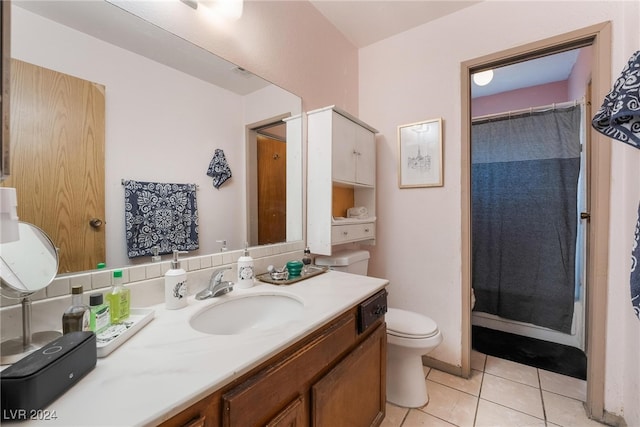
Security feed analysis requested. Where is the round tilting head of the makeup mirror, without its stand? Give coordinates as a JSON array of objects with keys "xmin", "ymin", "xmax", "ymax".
[{"xmin": 0, "ymin": 222, "xmax": 58, "ymax": 299}]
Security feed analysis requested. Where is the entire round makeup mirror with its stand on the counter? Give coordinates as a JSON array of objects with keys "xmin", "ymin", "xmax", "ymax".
[{"xmin": 0, "ymin": 222, "xmax": 61, "ymax": 365}]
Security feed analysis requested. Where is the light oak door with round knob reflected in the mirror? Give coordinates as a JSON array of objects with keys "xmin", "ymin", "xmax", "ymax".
[{"xmin": 2, "ymin": 60, "xmax": 105, "ymax": 273}]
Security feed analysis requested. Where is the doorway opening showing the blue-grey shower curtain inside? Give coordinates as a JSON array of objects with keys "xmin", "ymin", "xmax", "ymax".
[{"xmin": 471, "ymin": 46, "xmax": 591, "ymax": 360}]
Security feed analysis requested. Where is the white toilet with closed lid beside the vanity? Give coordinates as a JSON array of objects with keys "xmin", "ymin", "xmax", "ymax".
[{"xmin": 315, "ymin": 250, "xmax": 442, "ymax": 408}]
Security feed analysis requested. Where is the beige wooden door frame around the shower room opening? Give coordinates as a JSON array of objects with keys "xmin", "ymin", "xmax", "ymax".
[{"xmin": 460, "ymin": 22, "xmax": 611, "ymax": 421}]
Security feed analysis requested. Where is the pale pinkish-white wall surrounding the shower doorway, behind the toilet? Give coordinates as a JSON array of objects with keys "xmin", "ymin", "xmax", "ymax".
[{"xmin": 359, "ymin": 1, "xmax": 640, "ymax": 425}]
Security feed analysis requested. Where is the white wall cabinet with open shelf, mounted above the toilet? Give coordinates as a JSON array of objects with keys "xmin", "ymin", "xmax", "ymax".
[{"xmin": 307, "ymin": 106, "xmax": 377, "ymax": 255}]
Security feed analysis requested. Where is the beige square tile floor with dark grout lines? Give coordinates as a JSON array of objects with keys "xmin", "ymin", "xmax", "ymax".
[{"xmin": 382, "ymin": 351, "xmax": 602, "ymax": 427}]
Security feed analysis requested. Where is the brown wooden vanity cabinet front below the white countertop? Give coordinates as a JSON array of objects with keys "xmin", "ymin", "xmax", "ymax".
[{"xmin": 162, "ymin": 290, "xmax": 387, "ymax": 427}]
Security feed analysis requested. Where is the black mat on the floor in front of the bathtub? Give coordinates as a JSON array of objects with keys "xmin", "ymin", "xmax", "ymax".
[{"xmin": 471, "ymin": 326, "xmax": 587, "ymax": 380}]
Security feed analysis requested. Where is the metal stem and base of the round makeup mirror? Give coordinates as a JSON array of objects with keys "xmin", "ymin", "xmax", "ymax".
[{"xmin": 0, "ymin": 296, "xmax": 62, "ymax": 365}]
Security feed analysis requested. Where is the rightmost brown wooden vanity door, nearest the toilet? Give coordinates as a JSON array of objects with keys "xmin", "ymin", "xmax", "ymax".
[{"xmin": 311, "ymin": 323, "xmax": 387, "ymax": 427}]
